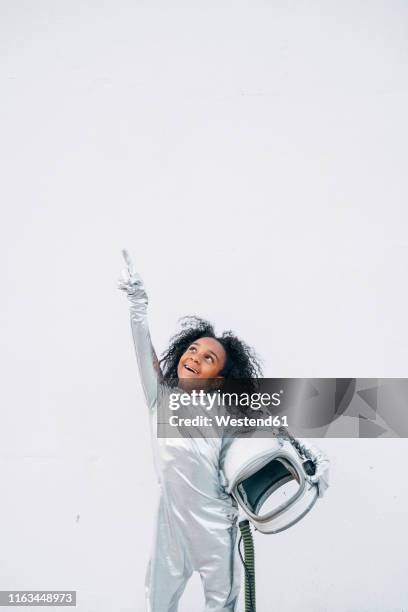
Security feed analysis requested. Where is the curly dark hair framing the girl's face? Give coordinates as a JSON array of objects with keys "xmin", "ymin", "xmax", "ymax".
[{"xmin": 160, "ymin": 316, "xmax": 262, "ymax": 386}]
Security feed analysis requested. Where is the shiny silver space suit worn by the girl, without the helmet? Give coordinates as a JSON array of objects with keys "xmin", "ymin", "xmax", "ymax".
[{"xmin": 118, "ymin": 262, "xmax": 241, "ymax": 612}]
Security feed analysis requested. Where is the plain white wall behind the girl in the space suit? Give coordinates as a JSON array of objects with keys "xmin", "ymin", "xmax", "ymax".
[{"xmin": 0, "ymin": 0, "xmax": 408, "ymax": 612}]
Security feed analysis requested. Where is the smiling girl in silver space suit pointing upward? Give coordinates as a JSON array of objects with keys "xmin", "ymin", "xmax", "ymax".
[{"xmin": 118, "ymin": 251, "xmax": 261, "ymax": 612}]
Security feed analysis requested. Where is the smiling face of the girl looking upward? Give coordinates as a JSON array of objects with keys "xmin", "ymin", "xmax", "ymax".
[{"xmin": 177, "ymin": 338, "xmax": 227, "ymax": 379}]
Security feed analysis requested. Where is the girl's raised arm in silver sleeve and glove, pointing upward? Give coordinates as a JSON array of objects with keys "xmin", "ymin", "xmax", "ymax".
[{"xmin": 118, "ymin": 250, "xmax": 162, "ymax": 410}]
